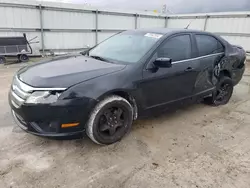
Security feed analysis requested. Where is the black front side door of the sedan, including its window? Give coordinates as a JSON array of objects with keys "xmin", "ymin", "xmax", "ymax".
[{"xmin": 141, "ymin": 34, "xmax": 199, "ymax": 109}]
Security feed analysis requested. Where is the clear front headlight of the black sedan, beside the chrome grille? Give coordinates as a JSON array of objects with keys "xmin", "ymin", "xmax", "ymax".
[{"xmin": 25, "ymin": 91, "xmax": 60, "ymax": 104}]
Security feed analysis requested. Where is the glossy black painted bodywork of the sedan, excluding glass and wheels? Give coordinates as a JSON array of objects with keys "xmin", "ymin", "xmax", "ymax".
[{"xmin": 10, "ymin": 29, "xmax": 245, "ymax": 136}]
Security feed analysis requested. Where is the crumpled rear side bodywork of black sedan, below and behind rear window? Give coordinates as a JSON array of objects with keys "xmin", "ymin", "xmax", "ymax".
[{"xmin": 195, "ymin": 36, "xmax": 246, "ymax": 92}]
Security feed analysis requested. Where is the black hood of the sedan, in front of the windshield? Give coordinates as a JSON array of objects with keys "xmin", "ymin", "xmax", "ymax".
[{"xmin": 18, "ymin": 55, "xmax": 125, "ymax": 88}]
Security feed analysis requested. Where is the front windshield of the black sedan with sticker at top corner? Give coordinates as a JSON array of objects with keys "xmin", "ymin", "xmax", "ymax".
[{"xmin": 89, "ymin": 32, "xmax": 162, "ymax": 63}]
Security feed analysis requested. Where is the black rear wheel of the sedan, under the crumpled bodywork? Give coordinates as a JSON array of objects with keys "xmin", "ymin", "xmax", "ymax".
[{"xmin": 205, "ymin": 76, "xmax": 234, "ymax": 106}]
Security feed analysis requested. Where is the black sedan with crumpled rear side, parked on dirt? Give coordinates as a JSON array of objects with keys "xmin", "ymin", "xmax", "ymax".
[{"xmin": 9, "ymin": 29, "xmax": 246, "ymax": 144}]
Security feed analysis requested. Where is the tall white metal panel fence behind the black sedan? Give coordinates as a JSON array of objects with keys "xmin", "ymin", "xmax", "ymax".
[{"xmin": 0, "ymin": 0, "xmax": 250, "ymax": 55}]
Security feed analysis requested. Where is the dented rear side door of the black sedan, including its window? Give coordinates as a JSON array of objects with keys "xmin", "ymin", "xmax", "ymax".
[{"xmin": 195, "ymin": 34, "xmax": 224, "ymax": 93}]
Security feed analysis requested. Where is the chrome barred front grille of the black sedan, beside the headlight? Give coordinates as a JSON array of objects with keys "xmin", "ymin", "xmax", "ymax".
[{"xmin": 10, "ymin": 76, "xmax": 32, "ymax": 108}]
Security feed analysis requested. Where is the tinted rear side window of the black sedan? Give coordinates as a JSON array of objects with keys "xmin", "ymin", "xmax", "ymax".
[{"xmin": 195, "ymin": 35, "xmax": 224, "ymax": 56}]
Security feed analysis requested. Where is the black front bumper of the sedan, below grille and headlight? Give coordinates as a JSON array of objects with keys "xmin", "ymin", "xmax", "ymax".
[{"xmin": 9, "ymin": 95, "xmax": 96, "ymax": 137}]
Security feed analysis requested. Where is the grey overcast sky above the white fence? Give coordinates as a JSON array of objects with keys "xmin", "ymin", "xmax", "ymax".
[{"xmin": 41, "ymin": 0, "xmax": 250, "ymax": 13}]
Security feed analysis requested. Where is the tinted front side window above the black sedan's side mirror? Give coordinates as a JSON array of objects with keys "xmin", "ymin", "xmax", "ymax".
[{"xmin": 157, "ymin": 35, "xmax": 191, "ymax": 61}]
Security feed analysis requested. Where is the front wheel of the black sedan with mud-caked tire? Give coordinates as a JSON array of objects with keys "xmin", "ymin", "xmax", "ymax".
[{"xmin": 86, "ymin": 95, "xmax": 133, "ymax": 145}]
